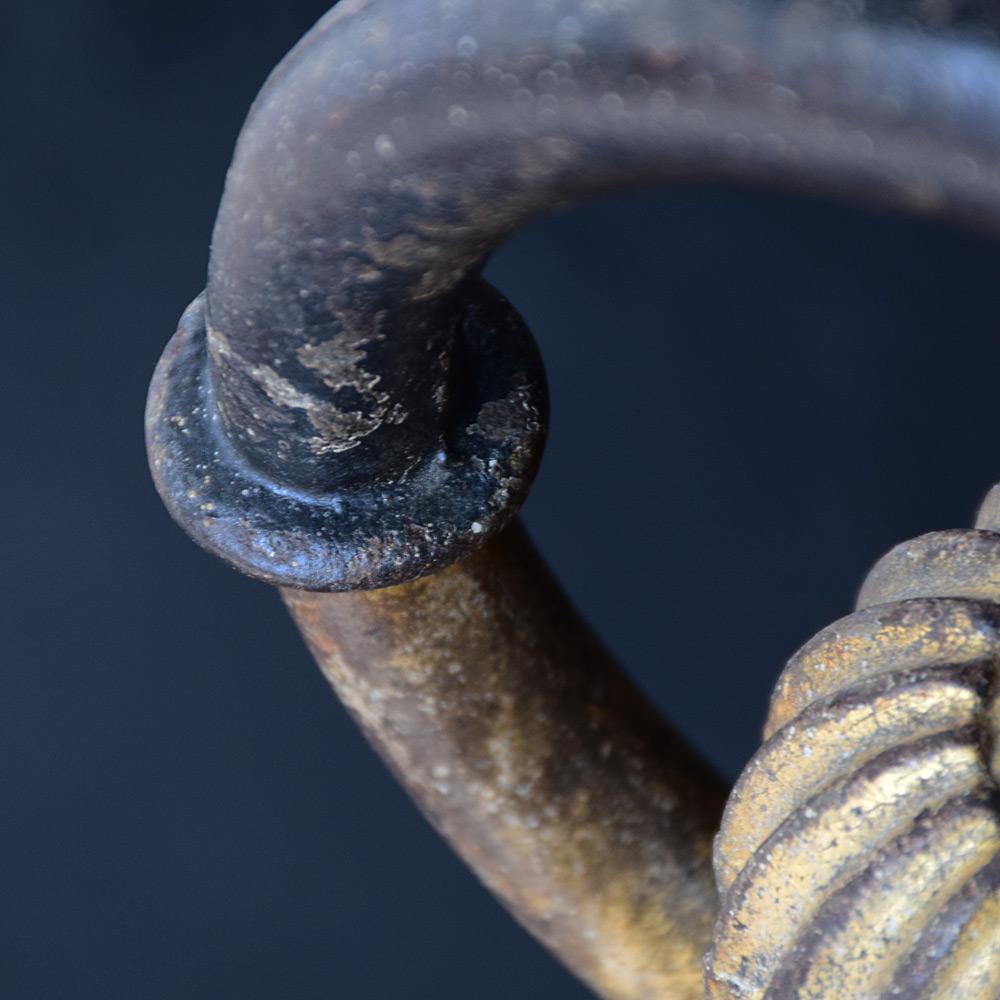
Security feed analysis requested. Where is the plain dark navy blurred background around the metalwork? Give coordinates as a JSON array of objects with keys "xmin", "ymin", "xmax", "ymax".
[{"xmin": 7, "ymin": 0, "xmax": 1000, "ymax": 1000}]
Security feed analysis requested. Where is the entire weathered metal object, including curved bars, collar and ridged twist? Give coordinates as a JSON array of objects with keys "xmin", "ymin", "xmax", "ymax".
[{"xmin": 147, "ymin": 0, "xmax": 1000, "ymax": 1000}]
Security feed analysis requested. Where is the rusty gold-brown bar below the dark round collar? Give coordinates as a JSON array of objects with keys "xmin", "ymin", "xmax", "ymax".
[{"xmin": 283, "ymin": 523, "xmax": 724, "ymax": 1000}]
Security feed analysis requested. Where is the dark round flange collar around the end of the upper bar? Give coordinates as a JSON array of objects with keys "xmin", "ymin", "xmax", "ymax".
[{"xmin": 146, "ymin": 282, "xmax": 548, "ymax": 591}]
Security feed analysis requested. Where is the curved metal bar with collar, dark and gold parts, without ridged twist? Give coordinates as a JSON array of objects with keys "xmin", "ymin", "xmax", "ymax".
[{"xmin": 147, "ymin": 0, "xmax": 1000, "ymax": 1000}]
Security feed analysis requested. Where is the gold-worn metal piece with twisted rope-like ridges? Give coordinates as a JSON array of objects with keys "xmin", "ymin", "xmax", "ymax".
[{"xmin": 708, "ymin": 506, "xmax": 1000, "ymax": 1000}]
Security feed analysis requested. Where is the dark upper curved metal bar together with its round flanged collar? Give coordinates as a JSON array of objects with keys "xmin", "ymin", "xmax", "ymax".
[{"xmin": 149, "ymin": 0, "xmax": 1000, "ymax": 590}]
